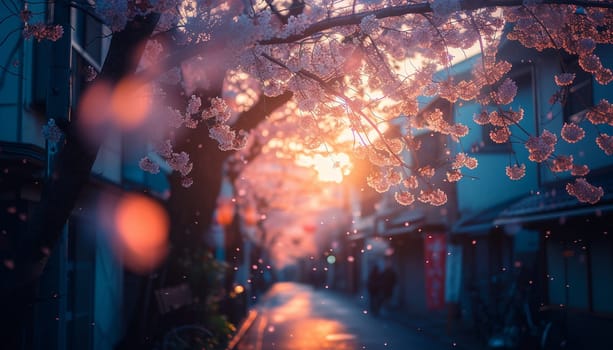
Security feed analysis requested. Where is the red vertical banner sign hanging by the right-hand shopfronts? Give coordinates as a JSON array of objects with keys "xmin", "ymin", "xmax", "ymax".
[{"xmin": 424, "ymin": 233, "xmax": 447, "ymax": 310}]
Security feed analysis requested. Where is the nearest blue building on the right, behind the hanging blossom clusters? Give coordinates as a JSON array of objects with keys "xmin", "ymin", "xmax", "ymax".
[{"xmin": 452, "ymin": 42, "xmax": 613, "ymax": 349}]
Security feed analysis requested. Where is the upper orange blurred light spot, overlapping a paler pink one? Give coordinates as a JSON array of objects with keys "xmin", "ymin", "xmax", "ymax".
[{"xmin": 110, "ymin": 78, "xmax": 151, "ymax": 130}]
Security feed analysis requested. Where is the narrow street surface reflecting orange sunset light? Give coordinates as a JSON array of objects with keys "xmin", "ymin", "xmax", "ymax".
[{"xmin": 236, "ymin": 282, "xmax": 460, "ymax": 350}]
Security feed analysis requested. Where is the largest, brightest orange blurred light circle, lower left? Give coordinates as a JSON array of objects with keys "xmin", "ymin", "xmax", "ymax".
[{"xmin": 114, "ymin": 194, "xmax": 169, "ymax": 273}]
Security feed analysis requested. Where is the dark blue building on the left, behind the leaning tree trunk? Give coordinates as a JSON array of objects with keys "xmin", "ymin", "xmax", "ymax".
[{"xmin": 0, "ymin": 2, "xmax": 167, "ymax": 349}]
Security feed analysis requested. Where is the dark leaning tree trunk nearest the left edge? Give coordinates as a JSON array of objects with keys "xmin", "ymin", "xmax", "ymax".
[{"xmin": 0, "ymin": 10, "xmax": 159, "ymax": 337}]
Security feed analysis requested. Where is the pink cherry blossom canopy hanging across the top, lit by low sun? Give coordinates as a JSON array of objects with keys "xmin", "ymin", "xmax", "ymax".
[{"xmin": 88, "ymin": 0, "xmax": 613, "ymax": 205}]
